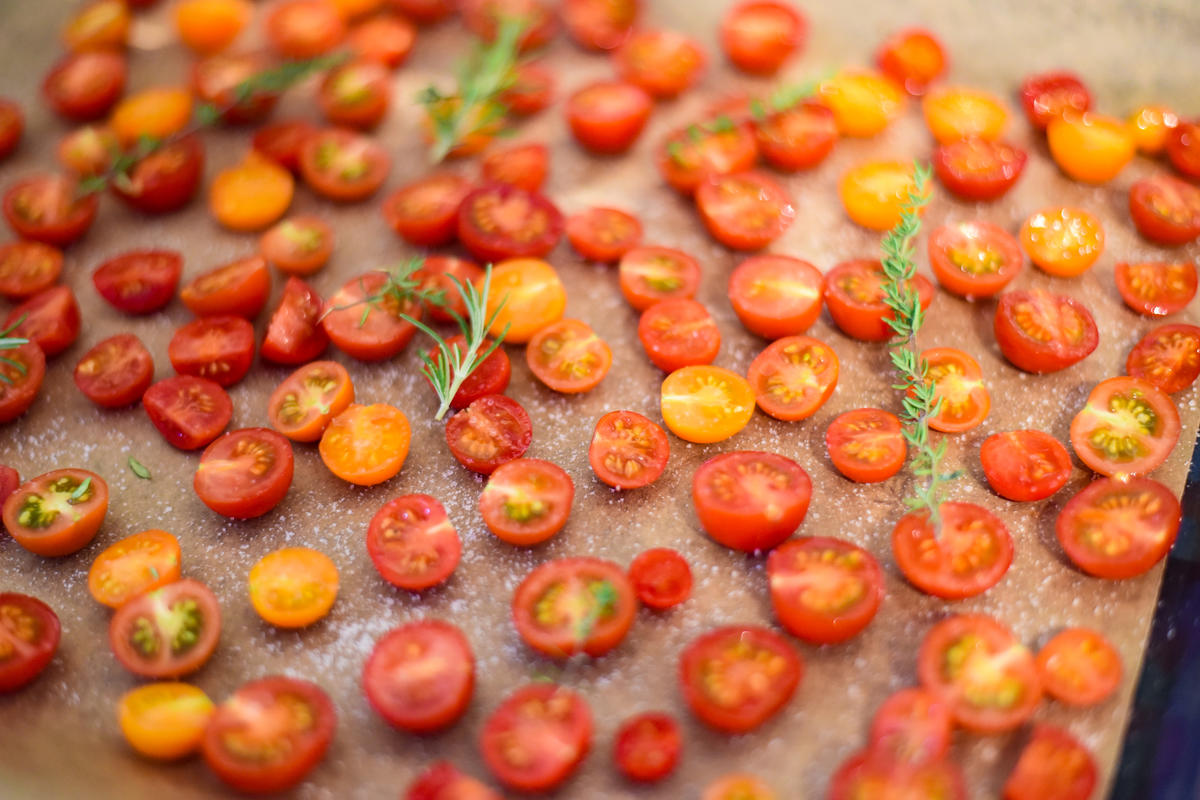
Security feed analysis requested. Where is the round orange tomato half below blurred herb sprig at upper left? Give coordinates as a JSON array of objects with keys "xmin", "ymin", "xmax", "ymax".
[{"xmin": 209, "ymin": 152, "xmax": 295, "ymax": 231}]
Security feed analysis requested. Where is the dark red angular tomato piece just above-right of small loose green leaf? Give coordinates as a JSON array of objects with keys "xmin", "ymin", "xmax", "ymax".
[{"xmin": 142, "ymin": 375, "xmax": 233, "ymax": 450}]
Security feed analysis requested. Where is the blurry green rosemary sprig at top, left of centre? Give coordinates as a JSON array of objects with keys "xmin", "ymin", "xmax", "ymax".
[{"xmin": 416, "ymin": 17, "xmax": 529, "ymax": 163}]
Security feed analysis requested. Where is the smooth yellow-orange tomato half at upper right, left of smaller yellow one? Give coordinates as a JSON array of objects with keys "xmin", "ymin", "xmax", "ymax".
[{"xmin": 1046, "ymin": 114, "xmax": 1136, "ymax": 184}]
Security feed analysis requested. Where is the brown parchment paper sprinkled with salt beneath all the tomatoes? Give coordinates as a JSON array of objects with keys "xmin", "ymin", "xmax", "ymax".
[{"xmin": 0, "ymin": 0, "xmax": 1200, "ymax": 800}]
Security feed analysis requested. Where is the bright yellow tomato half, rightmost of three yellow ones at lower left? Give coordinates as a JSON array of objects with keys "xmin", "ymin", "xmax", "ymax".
[{"xmin": 250, "ymin": 547, "xmax": 337, "ymax": 627}]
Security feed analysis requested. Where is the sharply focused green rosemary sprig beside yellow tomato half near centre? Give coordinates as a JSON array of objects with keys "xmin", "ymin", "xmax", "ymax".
[{"xmin": 400, "ymin": 264, "xmax": 509, "ymax": 420}]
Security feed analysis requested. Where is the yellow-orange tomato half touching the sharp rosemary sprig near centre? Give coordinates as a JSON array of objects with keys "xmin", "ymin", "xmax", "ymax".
[{"xmin": 476, "ymin": 258, "xmax": 566, "ymax": 344}]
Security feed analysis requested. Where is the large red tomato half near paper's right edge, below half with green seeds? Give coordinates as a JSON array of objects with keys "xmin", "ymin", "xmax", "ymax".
[{"xmin": 1055, "ymin": 476, "xmax": 1182, "ymax": 581}]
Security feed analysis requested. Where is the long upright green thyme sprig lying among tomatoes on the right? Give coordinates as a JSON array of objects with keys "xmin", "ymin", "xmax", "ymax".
[{"xmin": 881, "ymin": 163, "xmax": 959, "ymax": 531}]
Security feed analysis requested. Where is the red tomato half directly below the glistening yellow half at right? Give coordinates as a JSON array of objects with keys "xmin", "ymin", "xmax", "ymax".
[{"xmin": 992, "ymin": 289, "xmax": 1100, "ymax": 373}]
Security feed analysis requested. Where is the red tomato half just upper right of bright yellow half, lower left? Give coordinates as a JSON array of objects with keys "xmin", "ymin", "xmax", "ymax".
[{"xmin": 367, "ymin": 494, "xmax": 462, "ymax": 591}]
